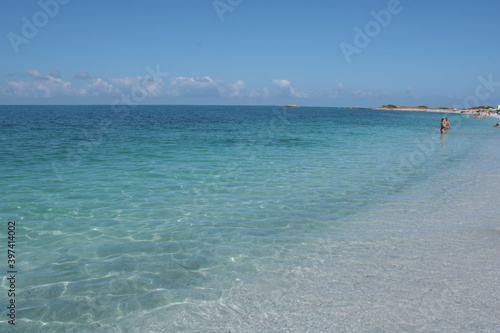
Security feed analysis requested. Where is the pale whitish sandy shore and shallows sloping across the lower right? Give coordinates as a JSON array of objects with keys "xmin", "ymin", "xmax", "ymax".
[{"xmin": 124, "ymin": 134, "xmax": 500, "ymax": 333}]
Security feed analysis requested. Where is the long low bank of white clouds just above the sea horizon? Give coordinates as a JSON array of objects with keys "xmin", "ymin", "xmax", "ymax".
[{"xmin": 0, "ymin": 68, "xmax": 382, "ymax": 102}]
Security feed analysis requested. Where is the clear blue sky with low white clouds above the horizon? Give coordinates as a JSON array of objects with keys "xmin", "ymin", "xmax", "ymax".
[{"xmin": 0, "ymin": 0, "xmax": 500, "ymax": 107}]
